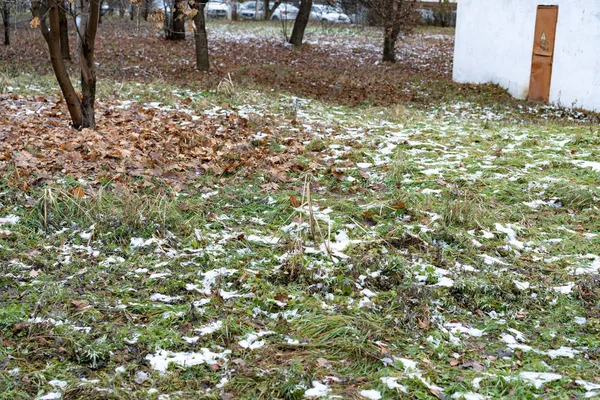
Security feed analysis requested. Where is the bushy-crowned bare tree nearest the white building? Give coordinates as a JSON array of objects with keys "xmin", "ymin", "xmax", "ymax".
[{"xmin": 362, "ymin": 0, "xmax": 417, "ymax": 62}]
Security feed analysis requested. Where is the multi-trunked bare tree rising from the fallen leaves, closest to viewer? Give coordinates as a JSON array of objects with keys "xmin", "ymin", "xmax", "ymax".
[{"xmin": 31, "ymin": 0, "xmax": 100, "ymax": 129}]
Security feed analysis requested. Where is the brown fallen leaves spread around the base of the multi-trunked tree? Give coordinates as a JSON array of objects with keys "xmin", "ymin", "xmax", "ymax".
[{"xmin": 0, "ymin": 95, "xmax": 310, "ymax": 189}]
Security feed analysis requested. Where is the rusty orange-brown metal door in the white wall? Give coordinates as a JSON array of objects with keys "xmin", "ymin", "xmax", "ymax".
[{"xmin": 529, "ymin": 6, "xmax": 558, "ymax": 103}]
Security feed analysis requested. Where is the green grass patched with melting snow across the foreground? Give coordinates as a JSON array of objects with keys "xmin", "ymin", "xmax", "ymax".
[{"xmin": 0, "ymin": 24, "xmax": 600, "ymax": 399}]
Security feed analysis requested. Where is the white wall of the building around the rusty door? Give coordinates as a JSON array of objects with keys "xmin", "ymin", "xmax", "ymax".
[{"xmin": 453, "ymin": 0, "xmax": 600, "ymax": 111}]
